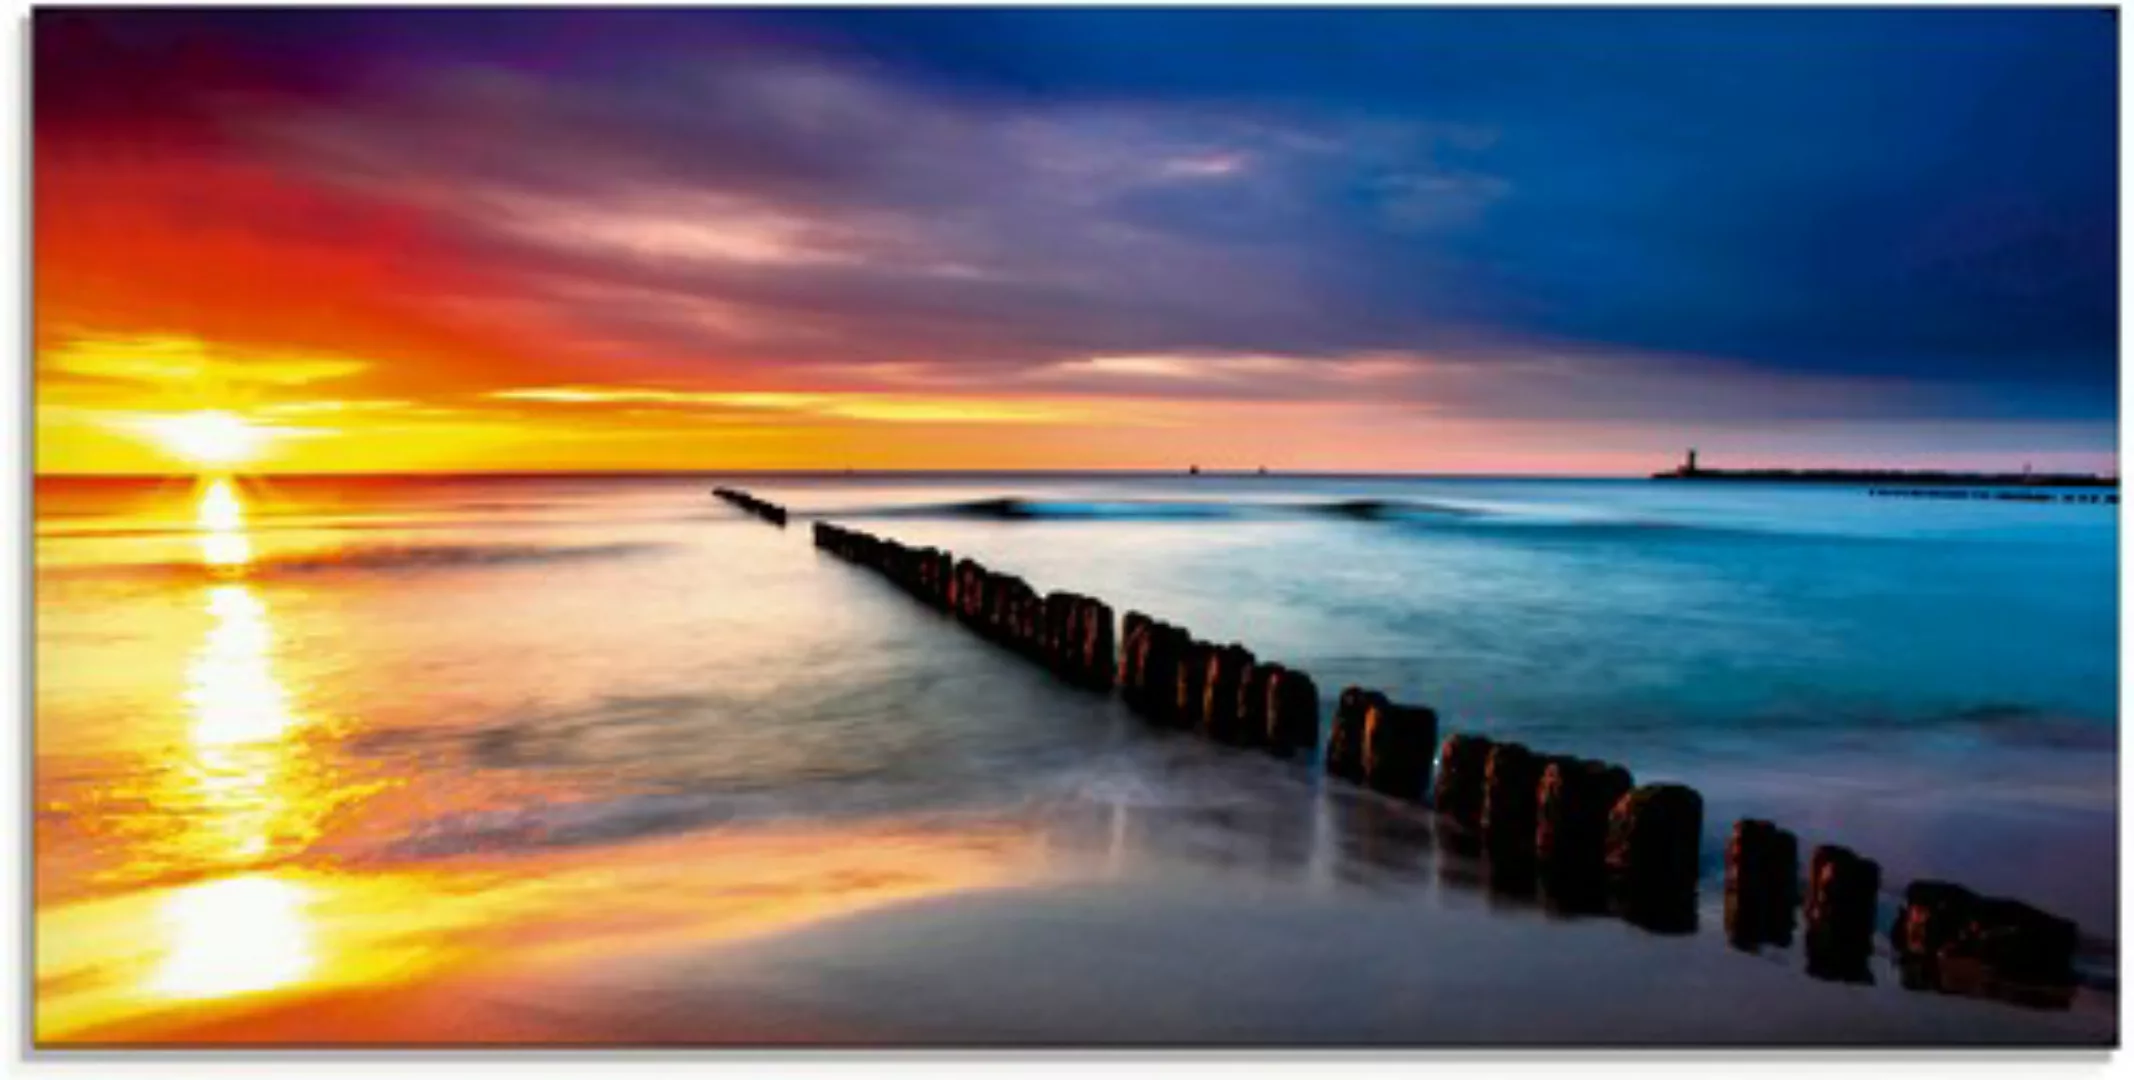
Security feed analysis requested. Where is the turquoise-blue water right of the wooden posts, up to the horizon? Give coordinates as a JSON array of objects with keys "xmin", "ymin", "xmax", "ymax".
[{"xmin": 806, "ymin": 480, "xmax": 2117, "ymax": 732}]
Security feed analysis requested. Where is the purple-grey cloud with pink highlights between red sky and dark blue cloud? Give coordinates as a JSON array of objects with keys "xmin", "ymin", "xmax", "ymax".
[{"xmin": 229, "ymin": 62, "xmax": 1519, "ymax": 384}]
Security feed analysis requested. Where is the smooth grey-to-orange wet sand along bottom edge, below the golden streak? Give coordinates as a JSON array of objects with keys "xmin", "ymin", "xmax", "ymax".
[{"xmin": 38, "ymin": 884, "xmax": 2117, "ymax": 1054}]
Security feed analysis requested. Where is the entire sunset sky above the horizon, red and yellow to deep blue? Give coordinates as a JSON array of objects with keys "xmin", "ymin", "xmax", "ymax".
[{"xmin": 32, "ymin": 9, "xmax": 2119, "ymax": 474}]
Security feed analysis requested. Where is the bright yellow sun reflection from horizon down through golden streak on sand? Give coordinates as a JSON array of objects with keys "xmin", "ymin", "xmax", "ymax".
[{"xmin": 34, "ymin": 478, "xmax": 1041, "ymax": 1044}]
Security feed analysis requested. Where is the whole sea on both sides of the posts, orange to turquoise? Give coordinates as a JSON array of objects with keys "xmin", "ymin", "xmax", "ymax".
[{"xmin": 32, "ymin": 474, "xmax": 2119, "ymax": 1037}]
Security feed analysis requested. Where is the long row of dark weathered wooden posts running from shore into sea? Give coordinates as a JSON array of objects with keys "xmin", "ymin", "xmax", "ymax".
[{"xmin": 725, "ymin": 493, "xmax": 2076, "ymax": 1005}]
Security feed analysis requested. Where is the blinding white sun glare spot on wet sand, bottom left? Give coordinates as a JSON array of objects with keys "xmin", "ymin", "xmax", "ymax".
[{"xmin": 149, "ymin": 875, "xmax": 316, "ymax": 997}]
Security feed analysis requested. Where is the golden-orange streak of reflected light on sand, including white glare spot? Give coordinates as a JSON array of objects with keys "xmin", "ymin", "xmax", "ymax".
[{"xmin": 34, "ymin": 824, "xmax": 1037, "ymax": 1044}]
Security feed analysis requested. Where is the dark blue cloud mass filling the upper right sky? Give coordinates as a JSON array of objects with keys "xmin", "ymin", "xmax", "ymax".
[{"xmin": 768, "ymin": 11, "xmax": 2119, "ymax": 399}]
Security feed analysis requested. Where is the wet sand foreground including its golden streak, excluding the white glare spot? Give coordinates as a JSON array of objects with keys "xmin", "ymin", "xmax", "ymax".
[{"xmin": 36, "ymin": 790, "xmax": 2117, "ymax": 1052}]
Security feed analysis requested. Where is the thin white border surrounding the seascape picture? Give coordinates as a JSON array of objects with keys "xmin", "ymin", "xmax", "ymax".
[{"xmin": 0, "ymin": 0, "xmax": 2134, "ymax": 1080}]
